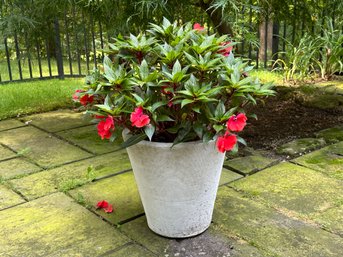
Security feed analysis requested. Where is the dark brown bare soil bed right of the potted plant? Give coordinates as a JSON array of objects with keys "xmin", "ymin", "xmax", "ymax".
[{"xmin": 241, "ymin": 94, "xmax": 343, "ymax": 150}]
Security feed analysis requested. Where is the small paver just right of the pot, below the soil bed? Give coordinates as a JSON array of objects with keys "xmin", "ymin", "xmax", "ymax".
[{"xmin": 224, "ymin": 155, "xmax": 275, "ymax": 175}]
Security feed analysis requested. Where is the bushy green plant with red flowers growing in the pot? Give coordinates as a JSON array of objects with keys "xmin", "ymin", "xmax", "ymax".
[{"xmin": 73, "ymin": 19, "xmax": 273, "ymax": 152}]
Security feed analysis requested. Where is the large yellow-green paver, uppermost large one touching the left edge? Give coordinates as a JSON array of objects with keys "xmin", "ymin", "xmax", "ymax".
[{"xmin": 0, "ymin": 127, "xmax": 91, "ymax": 168}]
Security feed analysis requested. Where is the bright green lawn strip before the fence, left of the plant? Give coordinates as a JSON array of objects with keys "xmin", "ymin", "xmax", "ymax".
[{"xmin": 0, "ymin": 78, "xmax": 83, "ymax": 120}]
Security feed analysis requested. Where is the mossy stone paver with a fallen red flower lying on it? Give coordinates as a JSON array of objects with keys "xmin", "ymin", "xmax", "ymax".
[{"xmin": 69, "ymin": 171, "xmax": 144, "ymax": 224}]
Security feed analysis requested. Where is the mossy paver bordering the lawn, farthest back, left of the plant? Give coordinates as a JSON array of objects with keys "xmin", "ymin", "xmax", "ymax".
[{"xmin": 23, "ymin": 110, "xmax": 90, "ymax": 132}]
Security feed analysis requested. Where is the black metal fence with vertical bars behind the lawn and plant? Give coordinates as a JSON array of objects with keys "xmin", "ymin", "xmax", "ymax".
[{"xmin": 0, "ymin": 3, "xmax": 340, "ymax": 83}]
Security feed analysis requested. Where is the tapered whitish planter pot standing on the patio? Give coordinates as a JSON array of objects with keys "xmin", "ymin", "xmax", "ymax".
[{"xmin": 123, "ymin": 131, "xmax": 225, "ymax": 238}]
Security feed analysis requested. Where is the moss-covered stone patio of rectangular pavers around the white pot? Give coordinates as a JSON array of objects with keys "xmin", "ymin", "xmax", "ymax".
[{"xmin": 0, "ymin": 110, "xmax": 343, "ymax": 257}]
